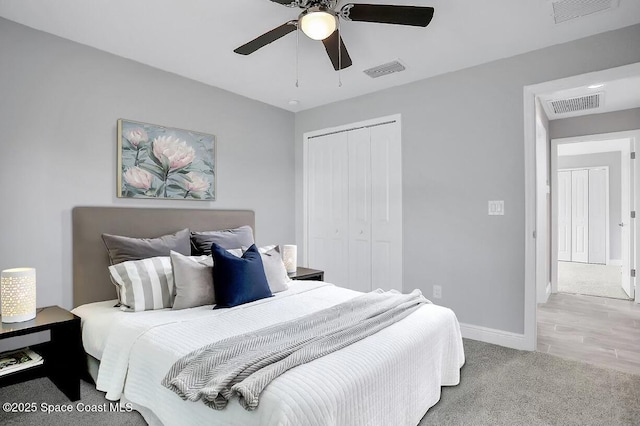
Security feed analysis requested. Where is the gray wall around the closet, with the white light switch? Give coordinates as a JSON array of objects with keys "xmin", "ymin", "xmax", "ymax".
[{"xmin": 295, "ymin": 25, "xmax": 640, "ymax": 333}]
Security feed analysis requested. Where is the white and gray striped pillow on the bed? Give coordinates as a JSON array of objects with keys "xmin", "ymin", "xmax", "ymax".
[{"xmin": 109, "ymin": 256, "xmax": 174, "ymax": 312}]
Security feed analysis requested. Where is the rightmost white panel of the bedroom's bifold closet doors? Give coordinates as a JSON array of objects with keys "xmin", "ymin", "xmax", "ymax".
[{"xmin": 371, "ymin": 123, "xmax": 402, "ymax": 291}]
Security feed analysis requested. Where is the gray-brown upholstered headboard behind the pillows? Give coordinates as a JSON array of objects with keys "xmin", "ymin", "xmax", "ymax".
[{"xmin": 72, "ymin": 207, "xmax": 255, "ymax": 307}]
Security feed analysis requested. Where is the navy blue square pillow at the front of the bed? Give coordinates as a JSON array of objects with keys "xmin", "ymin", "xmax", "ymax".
[{"xmin": 211, "ymin": 243, "xmax": 272, "ymax": 309}]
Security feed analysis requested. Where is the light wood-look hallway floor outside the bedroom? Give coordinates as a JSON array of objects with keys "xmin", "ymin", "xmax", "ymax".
[{"xmin": 537, "ymin": 293, "xmax": 640, "ymax": 374}]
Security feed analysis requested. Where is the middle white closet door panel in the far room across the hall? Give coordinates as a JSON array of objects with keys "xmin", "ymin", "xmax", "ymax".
[{"xmin": 571, "ymin": 170, "xmax": 589, "ymax": 263}]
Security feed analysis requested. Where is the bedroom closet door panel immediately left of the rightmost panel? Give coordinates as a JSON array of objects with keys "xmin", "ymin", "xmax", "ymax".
[{"xmin": 347, "ymin": 128, "xmax": 372, "ymax": 292}]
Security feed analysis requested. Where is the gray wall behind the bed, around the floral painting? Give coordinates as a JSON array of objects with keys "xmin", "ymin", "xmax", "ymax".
[{"xmin": 0, "ymin": 19, "xmax": 295, "ymax": 308}]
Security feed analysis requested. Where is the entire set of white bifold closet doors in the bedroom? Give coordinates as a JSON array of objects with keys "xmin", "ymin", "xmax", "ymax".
[{"xmin": 304, "ymin": 116, "xmax": 402, "ymax": 291}]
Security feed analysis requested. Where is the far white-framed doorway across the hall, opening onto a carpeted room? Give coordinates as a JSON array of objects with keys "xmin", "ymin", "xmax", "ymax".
[{"xmin": 551, "ymin": 140, "xmax": 633, "ymax": 300}]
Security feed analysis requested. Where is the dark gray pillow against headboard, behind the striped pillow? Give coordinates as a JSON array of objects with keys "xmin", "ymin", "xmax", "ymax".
[{"xmin": 102, "ymin": 229, "xmax": 191, "ymax": 265}]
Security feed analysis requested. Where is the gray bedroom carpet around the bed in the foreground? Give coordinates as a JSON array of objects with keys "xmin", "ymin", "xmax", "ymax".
[{"xmin": 0, "ymin": 339, "xmax": 640, "ymax": 426}]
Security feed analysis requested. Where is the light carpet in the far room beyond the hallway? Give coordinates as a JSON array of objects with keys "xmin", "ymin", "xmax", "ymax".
[{"xmin": 558, "ymin": 262, "xmax": 629, "ymax": 299}]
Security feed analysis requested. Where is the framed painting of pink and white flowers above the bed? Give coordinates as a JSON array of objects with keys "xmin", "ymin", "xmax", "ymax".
[{"xmin": 118, "ymin": 119, "xmax": 216, "ymax": 201}]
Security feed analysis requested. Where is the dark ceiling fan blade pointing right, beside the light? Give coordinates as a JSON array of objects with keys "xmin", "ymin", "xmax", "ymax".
[{"xmin": 340, "ymin": 3, "xmax": 434, "ymax": 27}]
